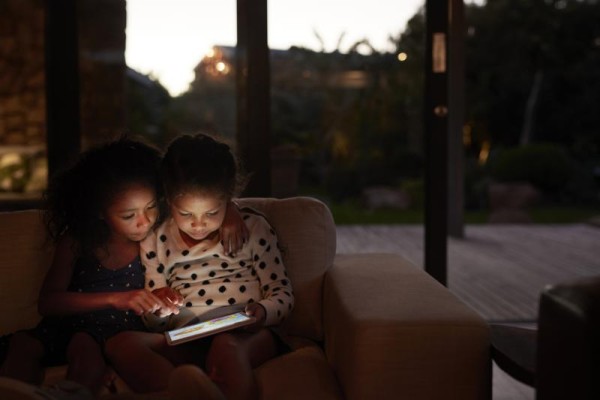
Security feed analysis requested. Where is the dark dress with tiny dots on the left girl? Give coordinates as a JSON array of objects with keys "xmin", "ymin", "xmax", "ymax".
[{"xmin": 28, "ymin": 257, "xmax": 146, "ymax": 365}]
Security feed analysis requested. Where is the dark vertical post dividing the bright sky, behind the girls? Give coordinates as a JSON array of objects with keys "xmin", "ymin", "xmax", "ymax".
[{"xmin": 236, "ymin": 0, "xmax": 271, "ymax": 196}]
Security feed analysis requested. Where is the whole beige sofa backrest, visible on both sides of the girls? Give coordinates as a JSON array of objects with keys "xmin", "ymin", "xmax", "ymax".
[{"xmin": 0, "ymin": 197, "xmax": 336, "ymax": 340}]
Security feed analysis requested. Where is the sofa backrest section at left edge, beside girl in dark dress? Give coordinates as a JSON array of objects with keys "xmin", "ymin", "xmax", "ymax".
[{"xmin": 0, "ymin": 210, "xmax": 53, "ymax": 335}]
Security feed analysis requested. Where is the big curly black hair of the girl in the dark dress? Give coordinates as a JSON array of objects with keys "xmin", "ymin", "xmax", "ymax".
[{"xmin": 44, "ymin": 137, "xmax": 162, "ymax": 255}]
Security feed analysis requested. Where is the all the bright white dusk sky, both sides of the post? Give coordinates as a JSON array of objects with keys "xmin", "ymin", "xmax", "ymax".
[{"xmin": 125, "ymin": 0, "xmax": 424, "ymax": 95}]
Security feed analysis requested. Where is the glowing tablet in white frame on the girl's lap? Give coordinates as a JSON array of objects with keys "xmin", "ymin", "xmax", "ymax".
[{"xmin": 165, "ymin": 312, "xmax": 256, "ymax": 346}]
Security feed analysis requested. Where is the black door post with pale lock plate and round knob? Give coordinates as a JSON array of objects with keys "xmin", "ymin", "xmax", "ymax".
[{"xmin": 424, "ymin": 0, "xmax": 451, "ymax": 285}]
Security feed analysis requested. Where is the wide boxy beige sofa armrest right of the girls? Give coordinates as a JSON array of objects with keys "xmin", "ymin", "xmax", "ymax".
[{"xmin": 323, "ymin": 254, "xmax": 491, "ymax": 400}]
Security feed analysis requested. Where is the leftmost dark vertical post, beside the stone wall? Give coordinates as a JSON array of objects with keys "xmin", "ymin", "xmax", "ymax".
[{"xmin": 44, "ymin": 0, "xmax": 81, "ymax": 176}]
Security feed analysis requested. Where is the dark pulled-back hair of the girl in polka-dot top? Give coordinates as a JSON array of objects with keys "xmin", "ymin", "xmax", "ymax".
[{"xmin": 161, "ymin": 133, "xmax": 246, "ymax": 199}]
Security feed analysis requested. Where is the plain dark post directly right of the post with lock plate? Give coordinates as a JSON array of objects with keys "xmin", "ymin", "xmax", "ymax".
[{"xmin": 448, "ymin": 0, "xmax": 465, "ymax": 238}]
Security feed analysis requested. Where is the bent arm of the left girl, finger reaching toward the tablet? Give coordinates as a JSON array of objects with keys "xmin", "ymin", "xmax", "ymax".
[{"xmin": 38, "ymin": 235, "xmax": 164, "ymax": 315}]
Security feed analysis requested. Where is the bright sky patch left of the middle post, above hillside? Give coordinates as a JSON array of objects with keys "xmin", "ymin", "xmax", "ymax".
[{"xmin": 125, "ymin": 0, "xmax": 237, "ymax": 96}]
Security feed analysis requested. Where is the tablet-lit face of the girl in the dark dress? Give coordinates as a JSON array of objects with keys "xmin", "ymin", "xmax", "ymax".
[{"xmin": 104, "ymin": 184, "xmax": 158, "ymax": 242}]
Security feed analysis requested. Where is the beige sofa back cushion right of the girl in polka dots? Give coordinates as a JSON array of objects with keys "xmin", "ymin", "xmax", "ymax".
[{"xmin": 237, "ymin": 197, "xmax": 336, "ymax": 340}]
